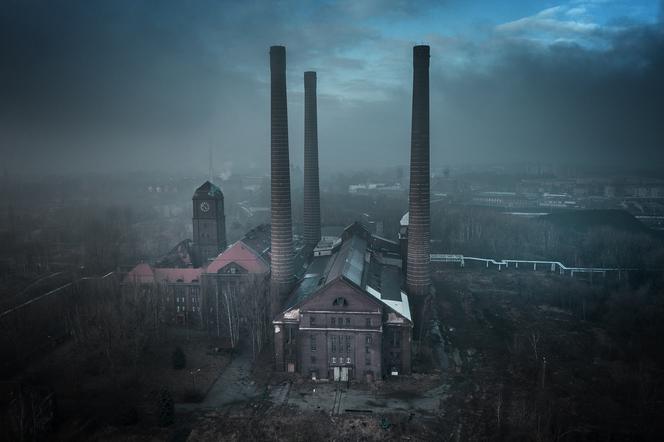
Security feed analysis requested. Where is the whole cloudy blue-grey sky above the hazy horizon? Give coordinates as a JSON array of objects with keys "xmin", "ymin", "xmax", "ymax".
[{"xmin": 0, "ymin": 0, "xmax": 664, "ymax": 173}]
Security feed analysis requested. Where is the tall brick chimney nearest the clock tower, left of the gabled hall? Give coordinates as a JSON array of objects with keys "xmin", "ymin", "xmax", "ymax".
[{"xmin": 270, "ymin": 46, "xmax": 294, "ymax": 311}]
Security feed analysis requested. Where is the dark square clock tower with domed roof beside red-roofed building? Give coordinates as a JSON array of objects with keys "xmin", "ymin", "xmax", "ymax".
[{"xmin": 192, "ymin": 181, "xmax": 226, "ymax": 265}]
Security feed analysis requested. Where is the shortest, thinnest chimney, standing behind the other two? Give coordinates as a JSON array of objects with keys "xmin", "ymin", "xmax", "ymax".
[{"xmin": 304, "ymin": 72, "xmax": 320, "ymax": 249}]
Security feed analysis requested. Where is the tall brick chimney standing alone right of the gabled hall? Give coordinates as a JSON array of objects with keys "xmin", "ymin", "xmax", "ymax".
[{"xmin": 406, "ymin": 46, "xmax": 431, "ymax": 297}]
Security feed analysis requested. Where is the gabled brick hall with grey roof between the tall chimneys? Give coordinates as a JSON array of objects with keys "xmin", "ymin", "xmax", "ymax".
[{"xmin": 273, "ymin": 223, "xmax": 413, "ymax": 381}]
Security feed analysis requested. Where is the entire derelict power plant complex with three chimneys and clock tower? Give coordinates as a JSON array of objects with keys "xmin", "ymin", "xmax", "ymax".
[{"xmin": 124, "ymin": 46, "xmax": 430, "ymax": 381}]
